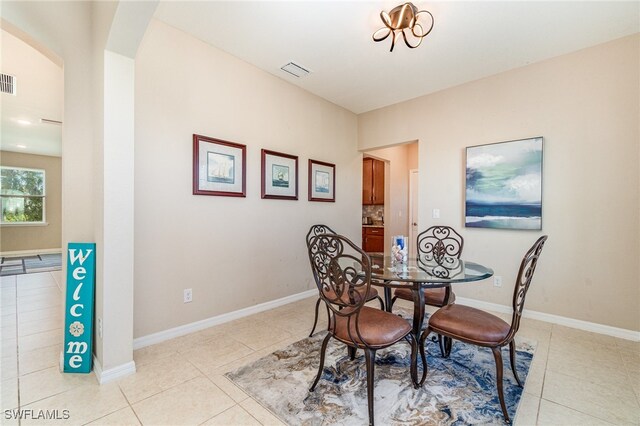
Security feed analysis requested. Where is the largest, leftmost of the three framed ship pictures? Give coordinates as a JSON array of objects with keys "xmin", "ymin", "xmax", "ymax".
[{"xmin": 193, "ymin": 135, "xmax": 247, "ymax": 197}]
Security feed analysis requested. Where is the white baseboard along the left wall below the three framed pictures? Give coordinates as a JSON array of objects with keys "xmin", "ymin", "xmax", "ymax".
[{"xmin": 133, "ymin": 289, "xmax": 318, "ymax": 350}]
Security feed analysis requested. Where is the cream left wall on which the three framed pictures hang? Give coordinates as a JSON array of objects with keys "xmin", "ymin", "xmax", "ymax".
[{"xmin": 134, "ymin": 21, "xmax": 362, "ymax": 337}]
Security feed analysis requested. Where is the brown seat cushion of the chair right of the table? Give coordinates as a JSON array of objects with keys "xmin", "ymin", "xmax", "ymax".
[{"xmin": 429, "ymin": 305, "xmax": 511, "ymax": 346}]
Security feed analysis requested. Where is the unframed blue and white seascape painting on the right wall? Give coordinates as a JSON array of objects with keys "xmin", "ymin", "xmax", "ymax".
[{"xmin": 465, "ymin": 137, "xmax": 542, "ymax": 230}]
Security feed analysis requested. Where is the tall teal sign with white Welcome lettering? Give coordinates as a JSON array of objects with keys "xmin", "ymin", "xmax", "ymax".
[{"xmin": 63, "ymin": 243, "xmax": 96, "ymax": 373}]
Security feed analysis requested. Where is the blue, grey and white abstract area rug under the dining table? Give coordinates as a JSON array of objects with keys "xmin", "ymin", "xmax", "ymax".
[{"xmin": 226, "ymin": 312, "xmax": 535, "ymax": 425}]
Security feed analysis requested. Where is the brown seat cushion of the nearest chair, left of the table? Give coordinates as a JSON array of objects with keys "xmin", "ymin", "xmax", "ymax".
[{"xmin": 330, "ymin": 306, "xmax": 411, "ymax": 349}]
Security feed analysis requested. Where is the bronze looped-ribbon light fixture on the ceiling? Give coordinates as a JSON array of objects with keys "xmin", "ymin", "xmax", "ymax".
[{"xmin": 373, "ymin": 2, "xmax": 434, "ymax": 52}]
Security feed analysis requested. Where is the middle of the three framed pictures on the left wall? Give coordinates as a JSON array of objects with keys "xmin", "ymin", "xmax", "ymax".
[{"xmin": 261, "ymin": 149, "xmax": 298, "ymax": 200}]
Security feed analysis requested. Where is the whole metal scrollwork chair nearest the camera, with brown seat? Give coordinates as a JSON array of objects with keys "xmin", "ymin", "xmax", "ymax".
[{"xmin": 309, "ymin": 234, "xmax": 426, "ymax": 425}]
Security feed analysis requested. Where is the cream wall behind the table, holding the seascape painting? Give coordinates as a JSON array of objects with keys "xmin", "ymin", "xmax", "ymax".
[{"xmin": 358, "ymin": 34, "xmax": 640, "ymax": 331}]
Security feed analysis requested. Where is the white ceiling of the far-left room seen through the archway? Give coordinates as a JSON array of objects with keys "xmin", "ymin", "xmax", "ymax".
[{"xmin": 0, "ymin": 30, "xmax": 64, "ymax": 157}]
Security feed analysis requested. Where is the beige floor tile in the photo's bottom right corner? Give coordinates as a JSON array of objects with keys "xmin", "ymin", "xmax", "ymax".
[{"xmin": 542, "ymin": 370, "xmax": 640, "ymax": 423}]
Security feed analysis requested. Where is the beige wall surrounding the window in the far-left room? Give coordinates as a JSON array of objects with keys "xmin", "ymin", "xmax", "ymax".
[{"xmin": 0, "ymin": 151, "xmax": 62, "ymax": 253}]
